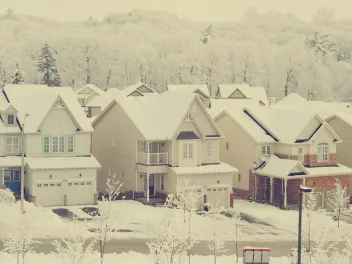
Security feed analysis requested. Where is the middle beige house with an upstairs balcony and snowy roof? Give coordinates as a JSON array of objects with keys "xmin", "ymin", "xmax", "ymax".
[{"xmin": 92, "ymin": 93, "xmax": 237, "ymax": 207}]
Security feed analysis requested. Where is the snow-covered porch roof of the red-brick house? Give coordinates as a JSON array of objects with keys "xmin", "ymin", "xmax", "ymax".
[{"xmin": 256, "ymin": 155, "xmax": 308, "ymax": 177}]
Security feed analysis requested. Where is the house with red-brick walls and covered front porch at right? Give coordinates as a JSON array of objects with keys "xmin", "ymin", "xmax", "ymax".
[{"xmin": 214, "ymin": 106, "xmax": 352, "ymax": 209}]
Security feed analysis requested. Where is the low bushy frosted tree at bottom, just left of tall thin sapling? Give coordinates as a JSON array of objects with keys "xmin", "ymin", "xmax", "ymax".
[{"xmin": 52, "ymin": 222, "xmax": 95, "ymax": 264}]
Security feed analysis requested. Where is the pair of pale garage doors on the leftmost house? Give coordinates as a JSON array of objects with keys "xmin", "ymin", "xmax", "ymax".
[{"xmin": 35, "ymin": 181, "xmax": 94, "ymax": 206}]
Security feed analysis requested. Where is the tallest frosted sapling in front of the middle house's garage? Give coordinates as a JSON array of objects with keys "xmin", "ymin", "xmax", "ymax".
[{"xmin": 177, "ymin": 177, "xmax": 202, "ymax": 263}]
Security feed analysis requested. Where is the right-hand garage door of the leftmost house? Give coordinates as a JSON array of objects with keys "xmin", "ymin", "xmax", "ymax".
[{"xmin": 66, "ymin": 181, "xmax": 94, "ymax": 205}]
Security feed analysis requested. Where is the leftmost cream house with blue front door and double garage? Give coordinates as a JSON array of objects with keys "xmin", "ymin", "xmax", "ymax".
[{"xmin": 0, "ymin": 85, "xmax": 100, "ymax": 206}]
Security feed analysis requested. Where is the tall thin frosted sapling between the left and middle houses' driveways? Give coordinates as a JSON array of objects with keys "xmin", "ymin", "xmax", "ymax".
[{"xmin": 93, "ymin": 174, "xmax": 122, "ymax": 264}]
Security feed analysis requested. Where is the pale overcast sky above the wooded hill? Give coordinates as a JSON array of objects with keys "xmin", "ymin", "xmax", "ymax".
[{"xmin": 0, "ymin": 0, "xmax": 352, "ymax": 21}]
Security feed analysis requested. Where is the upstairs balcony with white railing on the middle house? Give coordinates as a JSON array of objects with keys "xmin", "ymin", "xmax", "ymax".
[{"xmin": 137, "ymin": 141, "xmax": 171, "ymax": 166}]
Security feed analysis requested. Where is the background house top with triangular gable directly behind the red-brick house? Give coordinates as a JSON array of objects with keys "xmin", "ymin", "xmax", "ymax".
[{"xmin": 215, "ymin": 83, "xmax": 269, "ymax": 106}]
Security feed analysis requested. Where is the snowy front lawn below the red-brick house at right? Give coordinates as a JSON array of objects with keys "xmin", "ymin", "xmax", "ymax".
[{"xmin": 234, "ymin": 200, "xmax": 352, "ymax": 238}]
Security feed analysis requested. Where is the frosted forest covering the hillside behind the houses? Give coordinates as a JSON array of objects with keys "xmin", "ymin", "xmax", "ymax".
[{"xmin": 0, "ymin": 9, "xmax": 352, "ymax": 101}]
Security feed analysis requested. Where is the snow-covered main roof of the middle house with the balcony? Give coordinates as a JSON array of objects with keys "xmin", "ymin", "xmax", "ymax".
[{"xmin": 93, "ymin": 93, "xmax": 214, "ymax": 140}]
